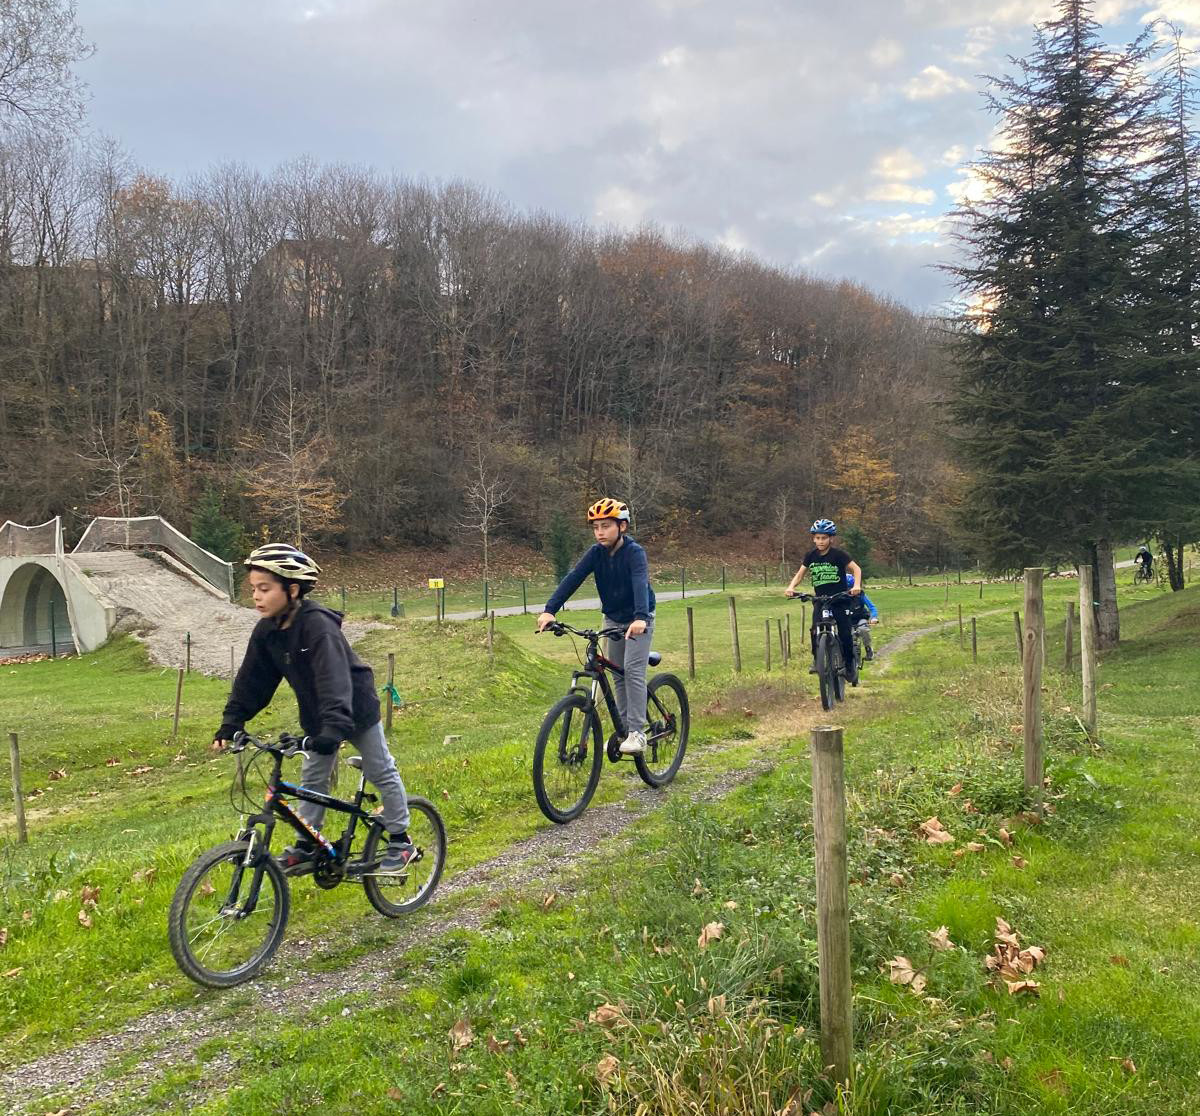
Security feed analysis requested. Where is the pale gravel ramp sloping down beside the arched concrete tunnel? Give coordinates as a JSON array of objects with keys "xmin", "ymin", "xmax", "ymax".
[{"xmin": 81, "ymin": 551, "xmax": 259, "ymax": 677}]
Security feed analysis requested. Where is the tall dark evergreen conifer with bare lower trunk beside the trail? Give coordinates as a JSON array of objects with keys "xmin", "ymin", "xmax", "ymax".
[{"xmin": 950, "ymin": 0, "xmax": 1169, "ymax": 646}]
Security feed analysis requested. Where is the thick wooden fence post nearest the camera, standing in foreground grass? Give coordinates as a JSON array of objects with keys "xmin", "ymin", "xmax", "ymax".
[{"xmin": 812, "ymin": 725, "xmax": 854, "ymax": 1081}]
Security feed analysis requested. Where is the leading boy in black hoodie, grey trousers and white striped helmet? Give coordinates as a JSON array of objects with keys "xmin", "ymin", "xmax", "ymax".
[{"xmin": 208, "ymin": 542, "xmax": 415, "ymax": 875}]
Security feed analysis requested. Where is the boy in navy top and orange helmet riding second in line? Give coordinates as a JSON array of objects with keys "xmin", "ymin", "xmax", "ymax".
[{"xmin": 538, "ymin": 497, "xmax": 654, "ymax": 756}]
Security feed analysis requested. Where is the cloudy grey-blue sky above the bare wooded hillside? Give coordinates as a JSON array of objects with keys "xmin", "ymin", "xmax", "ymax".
[{"xmin": 78, "ymin": 0, "xmax": 1200, "ymax": 310}]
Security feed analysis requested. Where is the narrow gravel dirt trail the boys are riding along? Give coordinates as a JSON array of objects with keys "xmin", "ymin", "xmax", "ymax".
[{"xmin": 0, "ymin": 614, "xmax": 931, "ymax": 1111}]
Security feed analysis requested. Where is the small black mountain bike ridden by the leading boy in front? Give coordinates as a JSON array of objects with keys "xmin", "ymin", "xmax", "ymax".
[{"xmin": 168, "ymin": 732, "xmax": 446, "ymax": 988}]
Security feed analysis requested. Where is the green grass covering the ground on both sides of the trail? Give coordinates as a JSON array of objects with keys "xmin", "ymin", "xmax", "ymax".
[{"xmin": 0, "ymin": 568, "xmax": 1200, "ymax": 1116}]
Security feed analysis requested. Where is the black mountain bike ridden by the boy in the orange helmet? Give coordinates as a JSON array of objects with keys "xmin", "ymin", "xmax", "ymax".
[{"xmin": 533, "ymin": 622, "xmax": 691, "ymax": 824}]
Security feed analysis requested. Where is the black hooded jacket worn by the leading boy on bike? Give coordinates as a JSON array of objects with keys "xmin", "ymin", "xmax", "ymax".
[{"xmin": 221, "ymin": 600, "xmax": 379, "ymax": 740}]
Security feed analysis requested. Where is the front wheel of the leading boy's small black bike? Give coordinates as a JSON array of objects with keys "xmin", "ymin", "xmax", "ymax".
[{"xmin": 168, "ymin": 841, "xmax": 292, "ymax": 988}]
